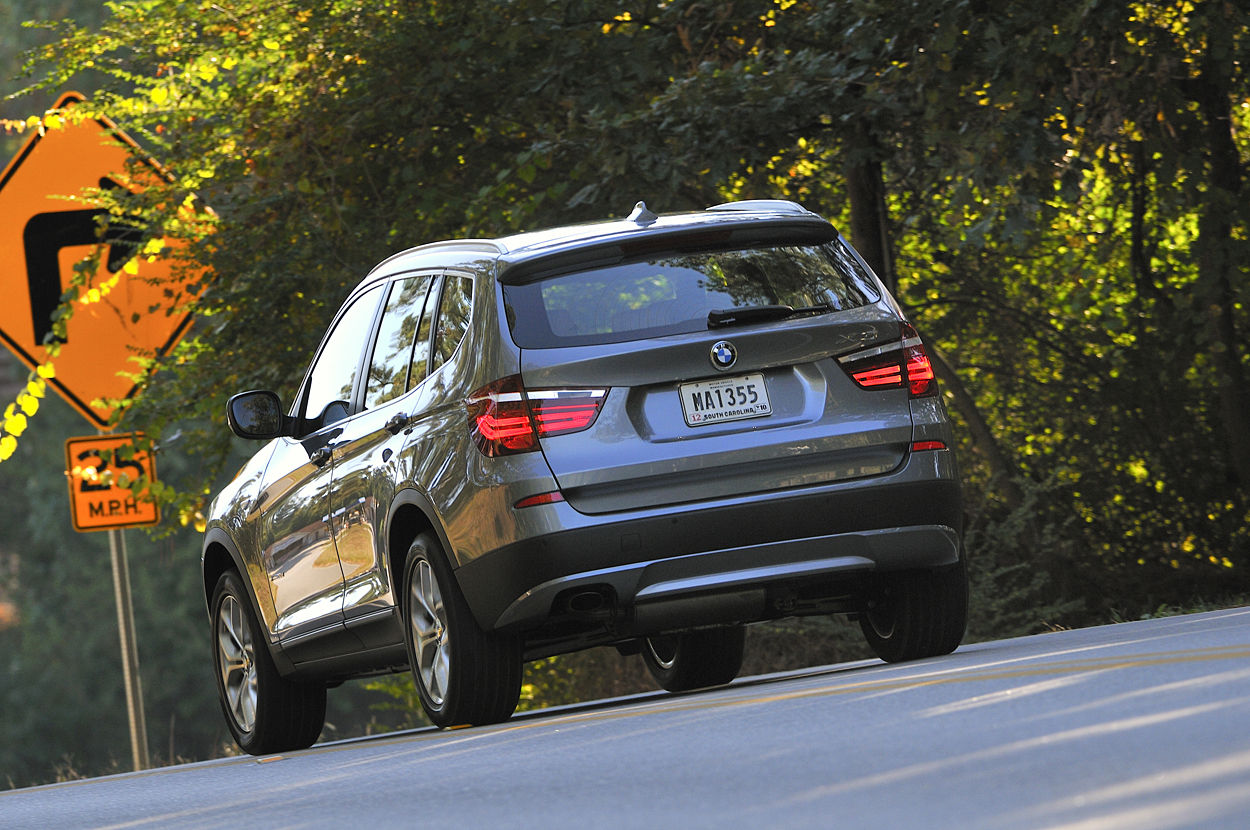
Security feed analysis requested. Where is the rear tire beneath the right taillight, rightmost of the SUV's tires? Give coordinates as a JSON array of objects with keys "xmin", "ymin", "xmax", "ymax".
[{"xmin": 860, "ymin": 561, "xmax": 968, "ymax": 663}]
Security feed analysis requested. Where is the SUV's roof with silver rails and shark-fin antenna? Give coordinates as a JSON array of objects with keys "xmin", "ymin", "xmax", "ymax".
[{"xmin": 365, "ymin": 199, "xmax": 829, "ymax": 281}]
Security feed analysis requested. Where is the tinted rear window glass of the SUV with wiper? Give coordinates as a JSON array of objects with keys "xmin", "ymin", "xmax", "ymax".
[{"xmin": 504, "ymin": 239, "xmax": 878, "ymax": 349}]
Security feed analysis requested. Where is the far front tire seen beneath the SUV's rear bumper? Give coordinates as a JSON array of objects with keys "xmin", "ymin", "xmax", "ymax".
[{"xmin": 643, "ymin": 625, "xmax": 746, "ymax": 691}]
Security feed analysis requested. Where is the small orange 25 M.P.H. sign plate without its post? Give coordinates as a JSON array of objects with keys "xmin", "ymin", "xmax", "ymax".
[{"xmin": 65, "ymin": 433, "xmax": 160, "ymax": 533}]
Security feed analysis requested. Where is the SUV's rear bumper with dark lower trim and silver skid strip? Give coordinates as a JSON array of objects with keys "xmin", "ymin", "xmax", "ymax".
[{"xmin": 456, "ymin": 453, "xmax": 961, "ymax": 630}]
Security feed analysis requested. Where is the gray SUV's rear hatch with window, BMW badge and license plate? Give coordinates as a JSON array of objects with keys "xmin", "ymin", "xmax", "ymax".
[{"xmin": 504, "ymin": 230, "xmax": 911, "ymax": 514}]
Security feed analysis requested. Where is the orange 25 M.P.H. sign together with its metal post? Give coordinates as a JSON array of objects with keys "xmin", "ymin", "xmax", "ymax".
[{"xmin": 65, "ymin": 434, "xmax": 160, "ymax": 771}]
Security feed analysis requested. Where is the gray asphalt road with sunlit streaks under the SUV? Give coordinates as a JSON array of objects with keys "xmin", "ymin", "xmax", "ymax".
[{"xmin": 0, "ymin": 609, "xmax": 1250, "ymax": 830}]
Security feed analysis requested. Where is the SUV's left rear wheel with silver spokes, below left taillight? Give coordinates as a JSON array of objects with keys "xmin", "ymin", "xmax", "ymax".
[{"xmin": 403, "ymin": 533, "xmax": 521, "ymax": 728}]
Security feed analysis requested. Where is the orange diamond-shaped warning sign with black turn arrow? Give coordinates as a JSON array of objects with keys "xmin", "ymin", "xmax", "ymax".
[{"xmin": 0, "ymin": 93, "xmax": 197, "ymax": 430}]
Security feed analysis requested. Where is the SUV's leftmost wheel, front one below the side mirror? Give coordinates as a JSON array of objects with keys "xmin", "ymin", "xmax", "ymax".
[{"xmin": 211, "ymin": 570, "xmax": 325, "ymax": 755}]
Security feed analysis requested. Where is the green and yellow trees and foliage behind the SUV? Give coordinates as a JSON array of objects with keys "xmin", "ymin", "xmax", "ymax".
[{"xmin": 0, "ymin": 0, "xmax": 1250, "ymax": 785}]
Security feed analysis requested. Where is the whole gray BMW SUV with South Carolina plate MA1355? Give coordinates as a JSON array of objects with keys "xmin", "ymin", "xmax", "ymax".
[{"xmin": 204, "ymin": 201, "xmax": 968, "ymax": 754}]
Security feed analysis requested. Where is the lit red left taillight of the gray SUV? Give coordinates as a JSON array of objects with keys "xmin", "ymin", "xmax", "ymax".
[{"xmin": 465, "ymin": 375, "xmax": 608, "ymax": 458}]
